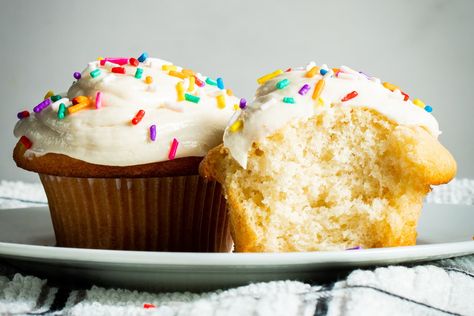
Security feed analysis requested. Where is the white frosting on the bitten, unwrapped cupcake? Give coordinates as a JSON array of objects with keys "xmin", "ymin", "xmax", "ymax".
[{"xmin": 224, "ymin": 64, "xmax": 440, "ymax": 168}]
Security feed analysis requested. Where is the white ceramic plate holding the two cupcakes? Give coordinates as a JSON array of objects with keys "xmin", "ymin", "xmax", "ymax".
[{"xmin": 0, "ymin": 204, "xmax": 474, "ymax": 290}]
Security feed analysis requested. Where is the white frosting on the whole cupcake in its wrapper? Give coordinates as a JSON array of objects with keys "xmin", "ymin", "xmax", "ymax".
[{"xmin": 14, "ymin": 58, "xmax": 238, "ymax": 166}]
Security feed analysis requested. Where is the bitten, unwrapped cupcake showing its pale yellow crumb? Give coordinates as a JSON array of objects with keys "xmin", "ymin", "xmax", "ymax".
[{"xmin": 200, "ymin": 63, "xmax": 456, "ymax": 252}]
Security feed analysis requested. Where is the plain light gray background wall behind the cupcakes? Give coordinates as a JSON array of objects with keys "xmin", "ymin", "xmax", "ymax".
[{"xmin": 0, "ymin": 0, "xmax": 474, "ymax": 181}]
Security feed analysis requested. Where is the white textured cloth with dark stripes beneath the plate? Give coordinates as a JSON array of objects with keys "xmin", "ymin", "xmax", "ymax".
[{"xmin": 0, "ymin": 179, "xmax": 474, "ymax": 316}]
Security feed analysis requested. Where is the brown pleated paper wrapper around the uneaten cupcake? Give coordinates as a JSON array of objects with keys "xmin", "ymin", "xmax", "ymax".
[{"xmin": 40, "ymin": 174, "xmax": 232, "ymax": 252}]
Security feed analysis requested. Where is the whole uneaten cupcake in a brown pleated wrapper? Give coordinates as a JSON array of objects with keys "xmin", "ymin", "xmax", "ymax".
[{"xmin": 13, "ymin": 53, "xmax": 238, "ymax": 252}]
